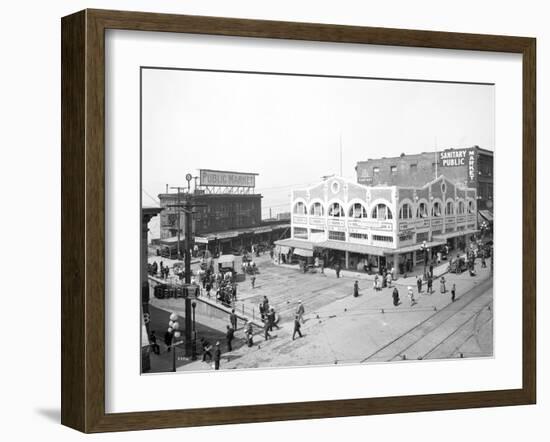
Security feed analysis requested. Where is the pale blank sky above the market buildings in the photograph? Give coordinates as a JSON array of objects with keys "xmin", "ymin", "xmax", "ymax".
[{"xmin": 142, "ymin": 69, "xmax": 495, "ymax": 216}]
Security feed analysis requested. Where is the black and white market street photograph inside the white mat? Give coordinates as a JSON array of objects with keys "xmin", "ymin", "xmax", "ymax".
[{"xmin": 141, "ymin": 66, "xmax": 496, "ymax": 374}]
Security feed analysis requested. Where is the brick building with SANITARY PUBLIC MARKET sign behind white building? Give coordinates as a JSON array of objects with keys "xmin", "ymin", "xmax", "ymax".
[{"xmin": 355, "ymin": 146, "xmax": 493, "ymax": 222}]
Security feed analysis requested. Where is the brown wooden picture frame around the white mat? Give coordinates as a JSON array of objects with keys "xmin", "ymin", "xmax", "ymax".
[{"xmin": 61, "ymin": 10, "xmax": 536, "ymax": 432}]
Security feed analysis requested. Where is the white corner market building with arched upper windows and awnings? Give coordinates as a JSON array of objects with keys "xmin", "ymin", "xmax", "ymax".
[{"xmin": 276, "ymin": 175, "xmax": 477, "ymax": 271}]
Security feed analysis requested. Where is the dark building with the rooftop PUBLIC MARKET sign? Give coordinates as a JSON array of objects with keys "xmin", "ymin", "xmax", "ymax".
[{"xmin": 158, "ymin": 169, "xmax": 290, "ymax": 253}]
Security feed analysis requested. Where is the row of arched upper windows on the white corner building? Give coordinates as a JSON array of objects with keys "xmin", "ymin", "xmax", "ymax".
[{"xmin": 293, "ymin": 200, "xmax": 475, "ymax": 219}]
